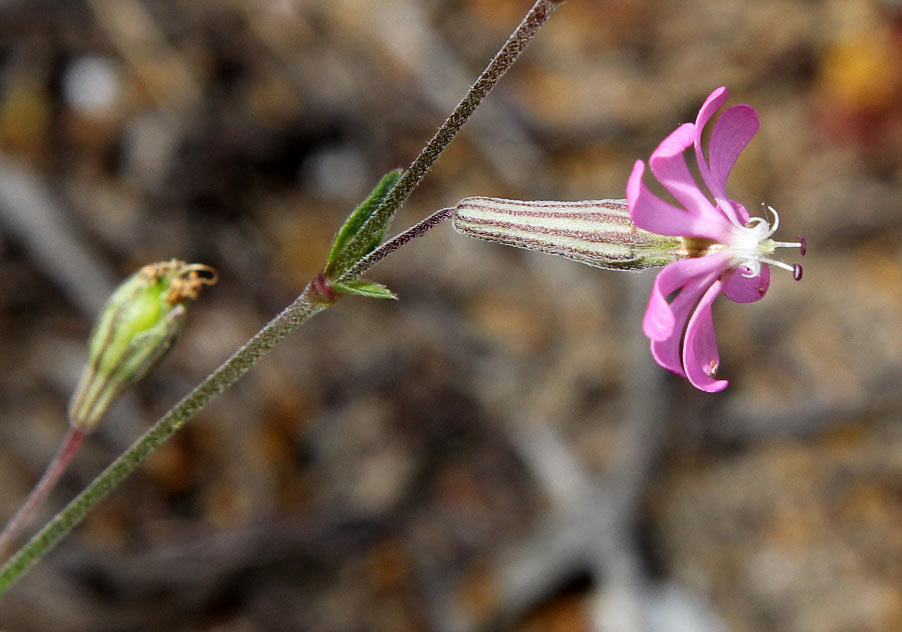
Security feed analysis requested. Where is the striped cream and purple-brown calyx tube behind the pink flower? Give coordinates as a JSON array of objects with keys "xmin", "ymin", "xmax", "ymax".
[{"xmin": 451, "ymin": 197, "xmax": 682, "ymax": 270}]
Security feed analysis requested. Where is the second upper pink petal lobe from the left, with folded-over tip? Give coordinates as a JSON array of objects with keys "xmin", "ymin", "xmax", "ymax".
[{"xmin": 648, "ymin": 123, "xmax": 717, "ymax": 217}]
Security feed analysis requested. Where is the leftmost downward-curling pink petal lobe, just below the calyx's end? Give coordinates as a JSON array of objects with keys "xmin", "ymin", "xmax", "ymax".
[{"xmin": 642, "ymin": 252, "xmax": 730, "ymax": 341}]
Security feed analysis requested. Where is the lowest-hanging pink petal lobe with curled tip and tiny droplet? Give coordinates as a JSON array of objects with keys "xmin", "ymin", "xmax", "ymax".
[{"xmin": 683, "ymin": 280, "xmax": 728, "ymax": 393}]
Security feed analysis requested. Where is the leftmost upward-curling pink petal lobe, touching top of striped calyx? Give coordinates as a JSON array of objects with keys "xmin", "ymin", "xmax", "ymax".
[{"xmin": 626, "ymin": 160, "xmax": 731, "ymax": 243}]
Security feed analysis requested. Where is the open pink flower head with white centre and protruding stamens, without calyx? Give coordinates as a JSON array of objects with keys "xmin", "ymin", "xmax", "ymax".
[{"xmin": 626, "ymin": 87, "xmax": 805, "ymax": 393}]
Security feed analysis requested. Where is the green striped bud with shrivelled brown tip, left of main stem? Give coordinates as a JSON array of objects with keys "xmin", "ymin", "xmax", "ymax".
[{"xmin": 69, "ymin": 259, "xmax": 217, "ymax": 433}]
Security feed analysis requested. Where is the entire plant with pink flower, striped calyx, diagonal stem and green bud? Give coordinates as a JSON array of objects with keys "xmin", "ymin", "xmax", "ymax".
[{"xmin": 0, "ymin": 0, "xmax": 806, "ymax": 594}]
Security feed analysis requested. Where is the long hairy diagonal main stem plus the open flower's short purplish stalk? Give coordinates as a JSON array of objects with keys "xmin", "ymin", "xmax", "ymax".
[{"xmin": 0, "ymin": 0, "xmax": 564, "ymax": 595}]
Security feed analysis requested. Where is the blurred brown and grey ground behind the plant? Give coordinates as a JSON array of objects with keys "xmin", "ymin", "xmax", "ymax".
[{"xmin": 0, "ymin": 0, "xmax": 902, "ymax": 632}]
